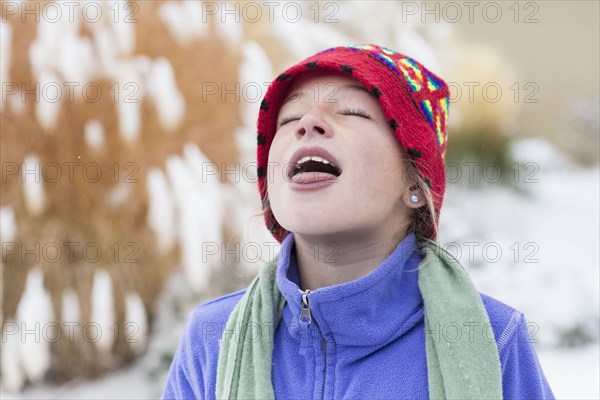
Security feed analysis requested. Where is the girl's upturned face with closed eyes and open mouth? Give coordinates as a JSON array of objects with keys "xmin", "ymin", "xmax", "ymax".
[{"xmin": 267, "ymin": 74, "xmax": 423, "ymax": 239}]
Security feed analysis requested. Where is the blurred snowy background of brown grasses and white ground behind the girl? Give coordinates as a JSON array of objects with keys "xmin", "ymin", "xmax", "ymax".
[{"xmin": 0, "ymin": 0, "xmax": 600, "ymax": 399}]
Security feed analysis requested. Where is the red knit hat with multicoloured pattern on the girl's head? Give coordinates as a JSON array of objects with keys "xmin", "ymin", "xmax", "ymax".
[{"xmin": 257, "ymin": 44, "xmax": 450, "ymax": 242}]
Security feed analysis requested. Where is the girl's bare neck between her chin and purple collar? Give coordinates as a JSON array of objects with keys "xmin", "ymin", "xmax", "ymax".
[{"xmin": 294, "ymin": 227, "xmax": 407, "ymax": 290}]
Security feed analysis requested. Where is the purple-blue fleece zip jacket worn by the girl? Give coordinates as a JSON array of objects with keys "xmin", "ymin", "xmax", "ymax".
[{"xmin": 163, "ymin": 233, "xmax": 554, "ymax": 399}]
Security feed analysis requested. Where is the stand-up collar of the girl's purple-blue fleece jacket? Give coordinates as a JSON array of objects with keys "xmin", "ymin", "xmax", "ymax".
[{"xmin": 277, "ymin": 233, "xmax": 423, "ymax": 346}]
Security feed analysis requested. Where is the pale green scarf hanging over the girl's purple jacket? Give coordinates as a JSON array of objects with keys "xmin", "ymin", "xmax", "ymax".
[{"xmin": 217, "ymin": 240, "xmax": 502, "ymax": 399}]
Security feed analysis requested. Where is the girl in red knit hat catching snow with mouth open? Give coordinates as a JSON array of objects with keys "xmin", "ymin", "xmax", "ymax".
[{"xmin": 163, "ymin": 45, "xmax": 553, "ymax": 399}]
